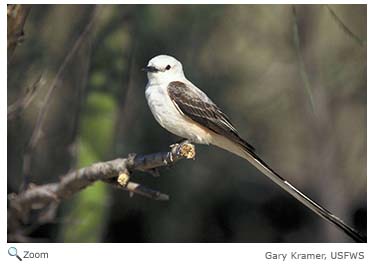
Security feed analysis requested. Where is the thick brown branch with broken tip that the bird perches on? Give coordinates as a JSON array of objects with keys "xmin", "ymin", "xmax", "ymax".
[{"xmin": 8, "ymin": 141, "xmax": 195, "ymax": 240}]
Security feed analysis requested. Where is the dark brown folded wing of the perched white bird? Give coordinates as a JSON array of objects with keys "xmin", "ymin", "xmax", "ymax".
[{"xmin": 167, "ymin": 81, "xmax": 255, "ymax": 152}]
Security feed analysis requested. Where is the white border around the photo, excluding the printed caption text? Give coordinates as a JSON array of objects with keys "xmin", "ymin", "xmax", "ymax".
[{"xmin": 0, "ymin": 0, "xmax": 373, "ymax": 266}]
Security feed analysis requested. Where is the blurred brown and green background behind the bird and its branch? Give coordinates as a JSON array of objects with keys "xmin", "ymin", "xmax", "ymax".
[{"xmin": 7, "ymin": 5, "xmax": 367, "ymax": 242}]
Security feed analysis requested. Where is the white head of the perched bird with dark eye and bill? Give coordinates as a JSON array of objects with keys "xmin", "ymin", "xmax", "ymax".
[{"xmin": 143, "ymin": 55, "xmax": 185, "ymax": 83}]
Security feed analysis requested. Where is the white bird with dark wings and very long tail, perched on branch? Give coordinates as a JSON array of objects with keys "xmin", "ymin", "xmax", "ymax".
[{"xmin": 143, "ymin": 55, "xmax": 366, "ymax": 242}]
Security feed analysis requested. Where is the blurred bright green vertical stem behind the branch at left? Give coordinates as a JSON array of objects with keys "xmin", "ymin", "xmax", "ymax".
[{"xmin": 60, "ymin": 92, "xmax": 116, "ymax": 242}]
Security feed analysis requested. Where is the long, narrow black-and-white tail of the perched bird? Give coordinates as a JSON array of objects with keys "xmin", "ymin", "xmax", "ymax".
[{"xmin": 212, "ymin": 136, "xmax": 367, "ymax": 243}]
